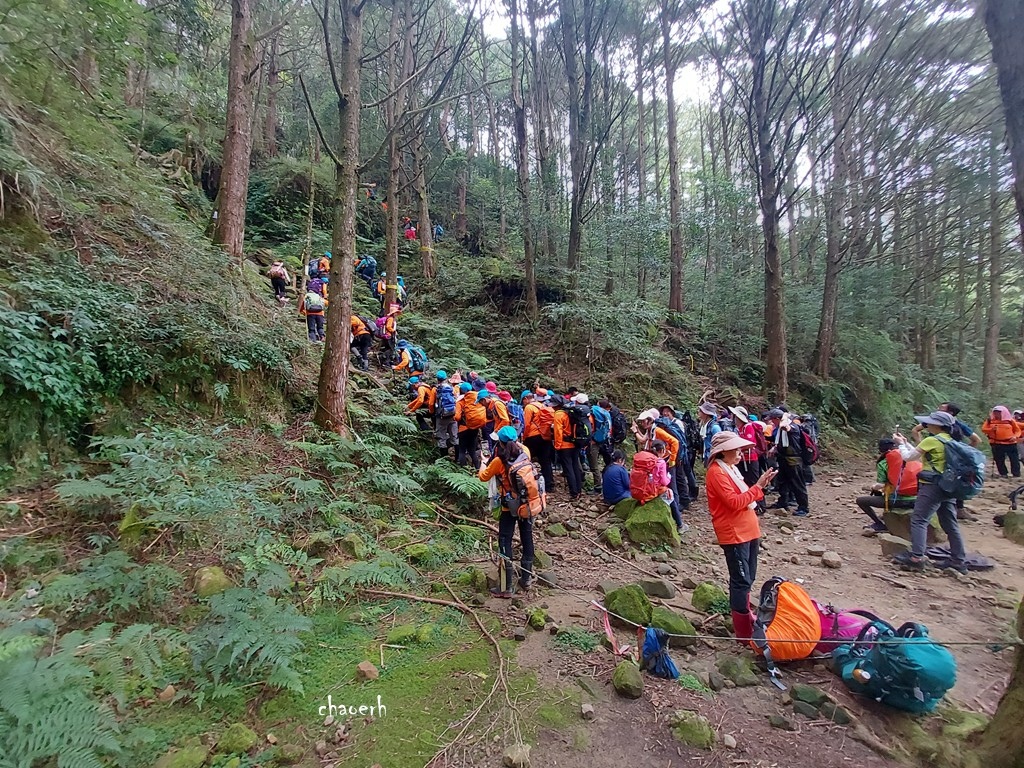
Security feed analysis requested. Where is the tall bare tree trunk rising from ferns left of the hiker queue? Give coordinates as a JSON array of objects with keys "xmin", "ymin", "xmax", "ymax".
[{"xmin": 313, "ymin": 0, "xmax": 364, "ymax": 434}]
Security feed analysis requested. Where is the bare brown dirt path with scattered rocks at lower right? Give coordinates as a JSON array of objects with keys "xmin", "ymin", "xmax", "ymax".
[{"xmin": 489, "ymin": 462, "xmax": 1024, "ymax": 768}]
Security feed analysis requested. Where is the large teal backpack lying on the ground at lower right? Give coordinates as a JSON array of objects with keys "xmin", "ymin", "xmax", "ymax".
[{"xmin": 833, "ymin": 620, "xmax": 956, "ymax": 713}]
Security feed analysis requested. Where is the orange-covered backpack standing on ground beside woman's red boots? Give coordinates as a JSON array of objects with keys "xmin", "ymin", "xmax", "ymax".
[{"xmin": 751, "ymin": 577, "xmax": 821, "ymax": 687}]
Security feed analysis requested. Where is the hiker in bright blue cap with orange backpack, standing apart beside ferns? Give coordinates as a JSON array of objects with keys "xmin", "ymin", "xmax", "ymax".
[{"xmin": 477, "ymin": 426, "xmax": 545, "ymax": 599}]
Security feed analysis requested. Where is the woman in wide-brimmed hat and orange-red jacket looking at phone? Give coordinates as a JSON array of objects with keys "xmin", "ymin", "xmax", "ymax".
[{"xmin": 705, "ymin": 432, "xmax": 776, "ymax": 641}]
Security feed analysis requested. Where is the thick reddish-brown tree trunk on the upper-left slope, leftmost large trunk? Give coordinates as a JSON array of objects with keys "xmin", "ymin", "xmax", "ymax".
[{"xmin": 211, "ymin": 0, "xmax": 256, "ymax": 263}]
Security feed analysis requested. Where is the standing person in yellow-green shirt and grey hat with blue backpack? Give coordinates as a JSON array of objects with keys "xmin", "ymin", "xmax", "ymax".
[{"xmin": 893, "ymin": 411, "xmax": 967, "ymax": 573}]
